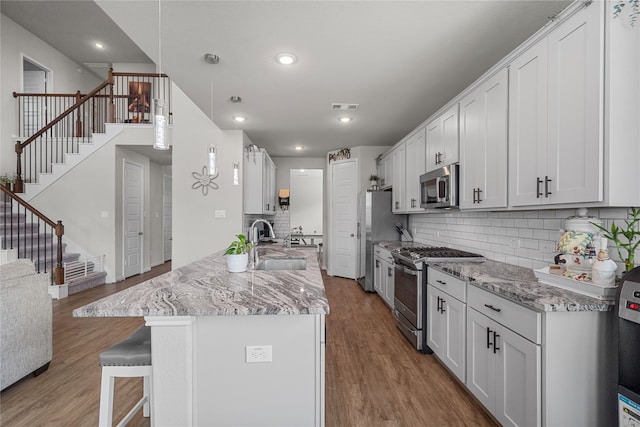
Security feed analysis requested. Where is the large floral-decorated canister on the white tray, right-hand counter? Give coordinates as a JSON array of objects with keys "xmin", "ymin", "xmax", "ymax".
[{"xmin": 555, "ymin": 209, "xmax": 602, "ymax": 274}]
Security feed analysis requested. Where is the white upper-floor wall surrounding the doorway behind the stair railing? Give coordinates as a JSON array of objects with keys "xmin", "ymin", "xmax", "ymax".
[{"xmin": 0, "ymin": 15, "xmax": 103, "ymax": 174}]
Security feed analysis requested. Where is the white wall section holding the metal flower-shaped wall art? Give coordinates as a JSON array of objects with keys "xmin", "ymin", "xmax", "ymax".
[{"xmin": 171, "ymin": 85, "xmax": 246, "ymax": 269}]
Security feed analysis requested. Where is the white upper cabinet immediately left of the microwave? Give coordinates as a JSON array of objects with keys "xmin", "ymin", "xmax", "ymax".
[{"xmin": 405, "ymin": 128, "xmax": 427, "ymax": 213}]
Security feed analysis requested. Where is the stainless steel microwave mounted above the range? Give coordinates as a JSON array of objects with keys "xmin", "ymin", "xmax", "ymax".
[{"xmin": 420, "ymin": 164, "xmax": 459, "ymax": 209}]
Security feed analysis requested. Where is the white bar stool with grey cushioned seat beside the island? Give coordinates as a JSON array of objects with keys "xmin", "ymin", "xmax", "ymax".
[{"xmin": 99, "ymin": 326, "xmax": 151, "ymax": 427}]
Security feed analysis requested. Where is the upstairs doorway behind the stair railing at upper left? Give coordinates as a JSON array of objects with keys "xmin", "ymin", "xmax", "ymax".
[{"xmin": 20, "ymin": 56, "xmax": 51, "ymax": 137}]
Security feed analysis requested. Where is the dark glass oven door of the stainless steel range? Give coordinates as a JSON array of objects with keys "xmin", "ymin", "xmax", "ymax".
[{"xmin": 393, "ymin": 262, "xmax": 423, "ymax": 350}]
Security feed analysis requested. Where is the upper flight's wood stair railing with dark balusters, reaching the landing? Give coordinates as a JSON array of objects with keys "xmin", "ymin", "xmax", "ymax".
[{"xmin": 13, "ymin": 70, "xmax": 172, "ymax": 193}]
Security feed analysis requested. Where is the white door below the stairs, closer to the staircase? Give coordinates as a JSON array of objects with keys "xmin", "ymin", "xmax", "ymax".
[{"xmin": 123, "ymin": 161, "xmax": 143, "ymax": 278}]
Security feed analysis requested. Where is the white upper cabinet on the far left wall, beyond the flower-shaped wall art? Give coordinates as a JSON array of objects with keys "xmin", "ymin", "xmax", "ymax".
[{"xmin": 244, "ymin": 149, "xmax": 276, "ymax": 215}]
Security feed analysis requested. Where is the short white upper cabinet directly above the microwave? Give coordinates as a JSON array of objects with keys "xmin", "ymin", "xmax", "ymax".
[{"xmin": 426, "ymin": 103, "xmax": 460, "ymax": 172}]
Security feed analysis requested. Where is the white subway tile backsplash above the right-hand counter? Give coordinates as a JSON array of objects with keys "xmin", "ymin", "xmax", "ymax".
[{"xmin": 409, "ymin": 208, "xmax": 640, "ymax": 274}]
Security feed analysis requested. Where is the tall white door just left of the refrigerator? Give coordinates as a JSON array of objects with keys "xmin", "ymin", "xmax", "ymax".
[{"xmin": 330, "ymin": 159, "xmax": 358, "ymax": 279}]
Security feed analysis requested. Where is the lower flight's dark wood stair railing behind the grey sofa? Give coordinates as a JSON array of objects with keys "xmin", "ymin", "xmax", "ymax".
[{"xmin": 0, "ymin": 186, "xmax": 64, "ymax": 285}]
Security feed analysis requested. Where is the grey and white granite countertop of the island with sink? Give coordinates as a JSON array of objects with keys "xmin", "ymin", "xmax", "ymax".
[{"xmin": 73, "ymin": 245, "xmax": 329, "ymax": 317}]
